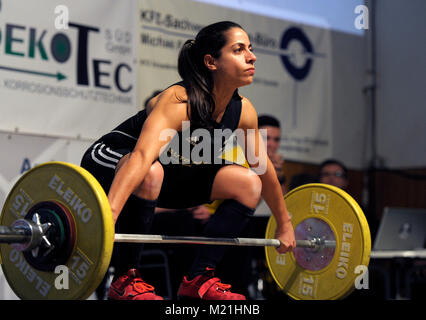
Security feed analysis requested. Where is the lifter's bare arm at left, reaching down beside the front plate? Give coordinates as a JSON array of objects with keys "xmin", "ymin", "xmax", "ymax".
[{"xmin": 108, "ymin": 86, "xmax": 187, "ymax": 222}]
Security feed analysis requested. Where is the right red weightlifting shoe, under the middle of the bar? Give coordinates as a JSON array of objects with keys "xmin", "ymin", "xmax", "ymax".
[{"xmin": 178, "ymin": 268, "xmax": 246, "ymax": 300}]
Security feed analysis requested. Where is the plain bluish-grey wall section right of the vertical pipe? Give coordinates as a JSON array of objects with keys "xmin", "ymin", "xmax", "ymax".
[{"xmin": 375, "ymin": 0, "xmax": 426, "ymax": 168}]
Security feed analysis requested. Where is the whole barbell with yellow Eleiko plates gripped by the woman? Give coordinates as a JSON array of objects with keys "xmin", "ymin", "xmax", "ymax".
[{"xmin": 0, "ymin": 162, "xmax": 371, "ymax": 300}]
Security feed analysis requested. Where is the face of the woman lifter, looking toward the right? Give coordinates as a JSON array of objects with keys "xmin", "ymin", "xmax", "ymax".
[{"xmin": 212, "ymin": 28, "xmax": 256, "ymax": 88}]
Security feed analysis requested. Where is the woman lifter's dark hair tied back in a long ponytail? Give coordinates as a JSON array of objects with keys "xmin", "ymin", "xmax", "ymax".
[{"xmin": 178, "ymin": 21, "xmax": 242, "ymax": 128}]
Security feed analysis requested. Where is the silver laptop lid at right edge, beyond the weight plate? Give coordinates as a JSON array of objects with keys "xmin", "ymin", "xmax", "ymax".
[{"xmin": 373, "ymin": 207, "xmax": 426, "ymax": 251}]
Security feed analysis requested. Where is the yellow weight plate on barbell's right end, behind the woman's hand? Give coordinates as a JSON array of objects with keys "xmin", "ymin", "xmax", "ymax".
[{"xmin": 265, "ymin": 183, "xmax": 371, "ymax": 300}]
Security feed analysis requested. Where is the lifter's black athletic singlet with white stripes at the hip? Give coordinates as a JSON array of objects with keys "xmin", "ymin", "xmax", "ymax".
[{"xmin": 81, "ymin": 82, "xmax": 242, "ymax": 209}]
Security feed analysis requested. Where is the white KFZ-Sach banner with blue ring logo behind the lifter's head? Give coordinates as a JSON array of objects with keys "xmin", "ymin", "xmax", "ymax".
[{"xmin": 139, "ymin": 0, "xmax": 332, "ymax": 162}]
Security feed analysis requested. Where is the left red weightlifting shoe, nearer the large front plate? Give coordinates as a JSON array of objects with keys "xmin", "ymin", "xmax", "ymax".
[{"xmin": 108, "ymin": 269, "xmax": 164, "ymax": 300}]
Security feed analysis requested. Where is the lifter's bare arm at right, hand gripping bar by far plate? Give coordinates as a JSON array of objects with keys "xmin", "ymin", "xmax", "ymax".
[{"xmin": 239, "ymin": 98, "xmax": 295, "ymax": 253}]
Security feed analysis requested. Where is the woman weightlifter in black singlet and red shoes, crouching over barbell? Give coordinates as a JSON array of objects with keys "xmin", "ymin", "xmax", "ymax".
[{"xmin": 81, "ymin": 21, "xmax": 295, "ymax": 300}]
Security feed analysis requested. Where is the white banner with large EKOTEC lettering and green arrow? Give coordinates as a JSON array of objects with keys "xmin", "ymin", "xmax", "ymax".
[{"xmin": 0, "ymin": 0, "xmax": 138, "ymax": 139}]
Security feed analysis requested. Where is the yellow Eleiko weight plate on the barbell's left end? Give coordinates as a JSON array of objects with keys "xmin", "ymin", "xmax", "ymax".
[{"xmin": 0, "ymin": 162, "xmax": 114, "ymax": 300}]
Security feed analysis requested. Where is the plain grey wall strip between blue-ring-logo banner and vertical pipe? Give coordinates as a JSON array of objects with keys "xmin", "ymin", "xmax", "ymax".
[{"xmin": 330, "ymin": 31, "xmax": 369, "ymax": 169}]
